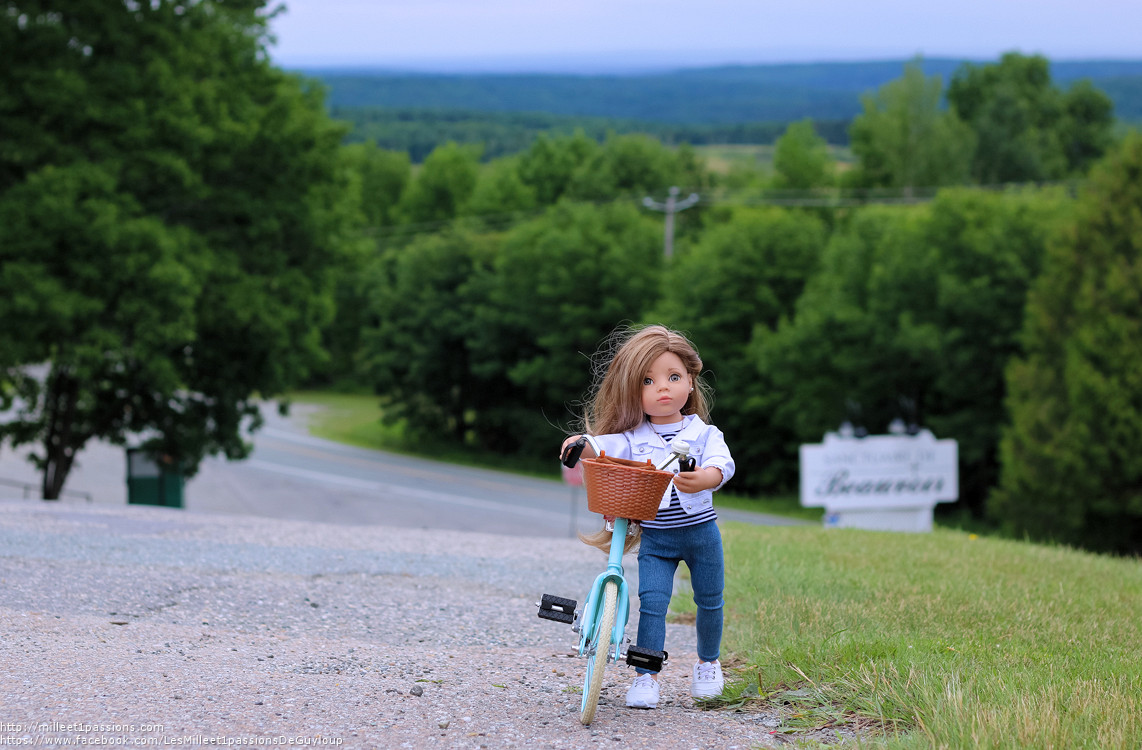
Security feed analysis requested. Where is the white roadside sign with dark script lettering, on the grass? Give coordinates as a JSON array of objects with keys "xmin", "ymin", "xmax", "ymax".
[{"xmin": 801, "ymin": 429, "xmax": 959, "ymax": 531}]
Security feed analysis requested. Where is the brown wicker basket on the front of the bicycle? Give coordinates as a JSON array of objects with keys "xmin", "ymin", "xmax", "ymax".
[{"xmin": 581, "ymin": 457, "xmax": 674, "ymax": 521}]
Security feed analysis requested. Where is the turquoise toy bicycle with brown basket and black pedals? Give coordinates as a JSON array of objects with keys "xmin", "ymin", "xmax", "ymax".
[{"xmin": 536, "ymin": 437, "xmax": 694, "ymax": 725}]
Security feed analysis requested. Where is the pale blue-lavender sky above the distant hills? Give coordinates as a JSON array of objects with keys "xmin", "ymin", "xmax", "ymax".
[{"xmin": 270, "ymin": 0, "xmax": 1142, "ymax": 73}]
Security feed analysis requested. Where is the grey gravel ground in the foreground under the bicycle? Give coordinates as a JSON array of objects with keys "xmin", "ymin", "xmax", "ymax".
[{"xmin": 0, "ymin": 500, "xmax": 840, "ymax": 749}]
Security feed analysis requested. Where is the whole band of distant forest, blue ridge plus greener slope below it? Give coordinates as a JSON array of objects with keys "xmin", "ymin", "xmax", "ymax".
[{"xmin": 307, "ymin": 59, "xmax": 1142, "ymax": 163}]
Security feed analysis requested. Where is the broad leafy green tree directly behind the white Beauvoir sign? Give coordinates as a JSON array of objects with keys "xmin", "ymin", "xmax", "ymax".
[{"xmin": 754, "ymin": 189, "xmax": 1067, "ymax": 502}]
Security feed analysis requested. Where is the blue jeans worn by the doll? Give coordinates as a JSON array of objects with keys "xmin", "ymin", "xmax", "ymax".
[{"xmin": 636, "ymin": 521, "xmax": 725, "ymax": 674}]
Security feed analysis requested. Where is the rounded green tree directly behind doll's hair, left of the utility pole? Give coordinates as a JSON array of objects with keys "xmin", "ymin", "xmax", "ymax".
[{"xmin": 467, "ymin": 202, "xmax": 661, "ymax": 455}]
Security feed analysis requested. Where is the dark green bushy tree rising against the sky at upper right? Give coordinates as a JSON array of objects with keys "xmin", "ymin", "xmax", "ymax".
[{"xmin": 948, "ymin": 53, "xmax": 1112, "ymax": 185}]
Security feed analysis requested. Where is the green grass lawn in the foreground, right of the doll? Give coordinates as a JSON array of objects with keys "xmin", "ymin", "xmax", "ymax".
[{"xmin": 724, "ymin": 524, "xmax": 1142, "ymax": 749}]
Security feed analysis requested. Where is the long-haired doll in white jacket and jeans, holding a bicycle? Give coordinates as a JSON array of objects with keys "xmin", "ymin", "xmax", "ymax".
[{"xmin": 561, "ymin": 325, "xmax": 734, "ymax": 709}]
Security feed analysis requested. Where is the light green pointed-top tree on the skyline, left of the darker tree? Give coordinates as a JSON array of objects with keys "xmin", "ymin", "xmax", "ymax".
[{"xmin": 849, "ymin": 63, "xmax": 973, "ymax": 193}]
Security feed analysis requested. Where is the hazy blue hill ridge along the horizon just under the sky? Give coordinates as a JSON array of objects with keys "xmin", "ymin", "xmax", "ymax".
[{"xmin": 299, "ymin": 58, "xmax": 1142, "ymax": 126}]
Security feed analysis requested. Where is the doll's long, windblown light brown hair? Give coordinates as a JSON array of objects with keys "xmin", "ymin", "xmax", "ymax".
[{"xmin": 579, "ymin": 325, "xmax": 711, "ymax": 553}]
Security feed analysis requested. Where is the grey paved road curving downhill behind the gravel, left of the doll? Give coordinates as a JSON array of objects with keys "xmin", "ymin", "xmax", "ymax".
[{"xmin": 0, "ymin": 404, "xmax": 797, "ymax": 537}]
